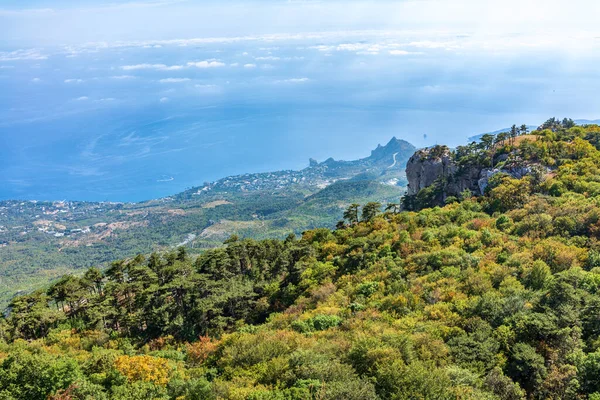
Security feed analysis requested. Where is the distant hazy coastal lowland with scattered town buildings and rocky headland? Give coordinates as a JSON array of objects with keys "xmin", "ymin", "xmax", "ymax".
[{"xmin": 0, "ymin": 138, "xmax": 415, "ymax": 305}]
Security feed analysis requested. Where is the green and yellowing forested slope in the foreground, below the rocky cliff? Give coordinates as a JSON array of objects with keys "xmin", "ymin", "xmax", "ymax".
[{"xmin": 5, "ymin": 120, "xmax": 600, "ymax": 400}]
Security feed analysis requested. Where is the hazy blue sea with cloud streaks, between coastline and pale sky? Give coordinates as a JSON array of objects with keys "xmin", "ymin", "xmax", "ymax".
[{"xmin": 0, "ymin": 31, "xmax": 600, "ymax": 201}]
